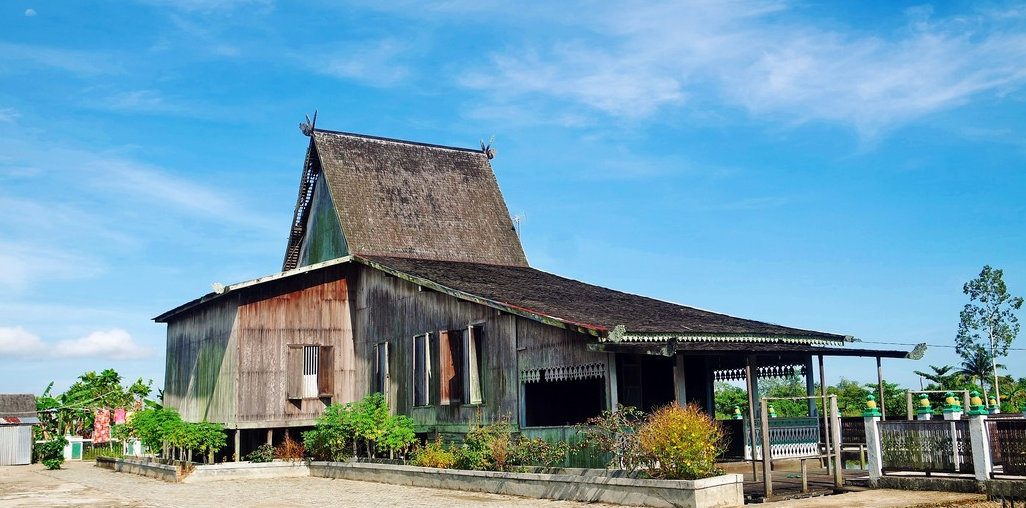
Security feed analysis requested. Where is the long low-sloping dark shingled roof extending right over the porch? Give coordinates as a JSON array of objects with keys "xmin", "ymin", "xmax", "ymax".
[{"xmin": 356, "ymin": 257, "xmax": 845, "ymax": 344}]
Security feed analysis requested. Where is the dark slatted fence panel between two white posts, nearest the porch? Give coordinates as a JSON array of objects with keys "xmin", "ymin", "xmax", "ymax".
[{"xmin": 879, "ymin": 420, "xmax": 974, "ymax": 473}]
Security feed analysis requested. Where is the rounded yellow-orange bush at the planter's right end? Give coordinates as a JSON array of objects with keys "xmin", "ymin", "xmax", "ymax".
[{"xmin": 637, "ymin": 402, "xmax": 724, "ymax": 479}]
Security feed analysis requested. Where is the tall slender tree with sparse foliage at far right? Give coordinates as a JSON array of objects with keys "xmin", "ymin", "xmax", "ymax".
[{"xmin": 955, "ymin": 265, "xmax": 1023, "ymax": 400}]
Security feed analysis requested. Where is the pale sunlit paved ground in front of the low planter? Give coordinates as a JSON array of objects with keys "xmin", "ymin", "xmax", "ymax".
[{"xmin": 0, "ymin": 462, "xmax": 999, "ymax": 508}]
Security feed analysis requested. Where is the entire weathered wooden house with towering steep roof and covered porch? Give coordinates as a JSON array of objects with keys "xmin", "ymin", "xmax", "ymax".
[{"xmin": 155, "ymin": 129, "xmax": 904, "ymax": 461}]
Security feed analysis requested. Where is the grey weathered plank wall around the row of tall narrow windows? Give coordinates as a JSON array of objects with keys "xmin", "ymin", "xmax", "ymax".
[{"xmin": 352, "ymin": 267, "xmax": 519, "ymax": 432}]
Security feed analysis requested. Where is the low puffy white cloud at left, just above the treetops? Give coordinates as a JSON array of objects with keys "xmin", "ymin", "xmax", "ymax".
[{"xmin": 0, "ymin": 326, "xmax": 153, "ymax": 360}]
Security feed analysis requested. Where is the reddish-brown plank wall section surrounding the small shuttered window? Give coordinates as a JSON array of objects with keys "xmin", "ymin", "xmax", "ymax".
[{"xmin": 238, "ymin": 270, "xmax": 356, "ymax": 426}]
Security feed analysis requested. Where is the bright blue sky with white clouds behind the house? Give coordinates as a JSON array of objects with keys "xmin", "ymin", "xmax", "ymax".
[{"xmin": 0, "ymin": 0, "xmax": 1026, "ymax": 394}]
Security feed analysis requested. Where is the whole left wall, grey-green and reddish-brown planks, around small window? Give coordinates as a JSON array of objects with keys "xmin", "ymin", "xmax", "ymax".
[{"xmin": 164, "ymin": 268, "xmax": 357, "ymax": 428}]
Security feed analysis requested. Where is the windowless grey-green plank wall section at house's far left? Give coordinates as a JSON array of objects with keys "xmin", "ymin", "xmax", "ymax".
[{"xmin": 164, "ymin": 296, "xmax": 239, "ymax": 425}]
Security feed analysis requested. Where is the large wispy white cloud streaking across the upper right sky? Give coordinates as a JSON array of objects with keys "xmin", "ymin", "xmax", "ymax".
[{"xmin": 461, "ymin": 0, "xmax": 1026, "ymax": 135}]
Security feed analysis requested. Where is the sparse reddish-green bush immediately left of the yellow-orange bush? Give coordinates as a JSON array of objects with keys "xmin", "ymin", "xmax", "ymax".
[{"xmin": 577, "ymin": 404, "xmax": 646, "ymax": 472}]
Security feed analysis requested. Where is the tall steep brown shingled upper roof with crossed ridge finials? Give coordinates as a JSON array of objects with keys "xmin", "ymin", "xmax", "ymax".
[{"xmin": 283, "ymin": 129, "xmax": 527, "ymax": 270}]
